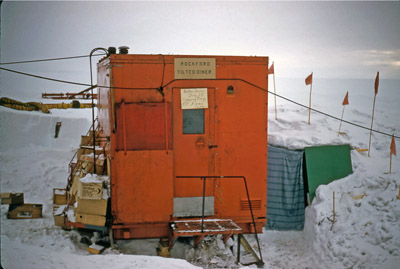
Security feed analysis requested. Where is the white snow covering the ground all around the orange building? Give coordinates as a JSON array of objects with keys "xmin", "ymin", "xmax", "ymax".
[{"xmin": 0, "ymin": 78, "xmax": 400, "ymax": 268}]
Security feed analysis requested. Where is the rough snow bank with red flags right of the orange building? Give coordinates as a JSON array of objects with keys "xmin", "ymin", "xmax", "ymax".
[{"xmin": 261, "ymin": 78, "xmax": 400, "ymax": 268}]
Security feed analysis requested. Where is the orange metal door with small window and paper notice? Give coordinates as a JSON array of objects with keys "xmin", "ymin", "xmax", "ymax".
[{"xmin": 173, "ymin": 88, "xmax": 217, "ymax": 217}]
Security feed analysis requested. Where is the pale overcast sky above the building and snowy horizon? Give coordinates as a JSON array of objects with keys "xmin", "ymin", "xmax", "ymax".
[{"xmin": 1, "ymin": 1, "xmax": 400, "ymax": 96}]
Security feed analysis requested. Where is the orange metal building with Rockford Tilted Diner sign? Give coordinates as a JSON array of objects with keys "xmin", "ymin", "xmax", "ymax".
[{"xmin": 97, "ymin": 54, "xmax": 268, "ymax": 239}]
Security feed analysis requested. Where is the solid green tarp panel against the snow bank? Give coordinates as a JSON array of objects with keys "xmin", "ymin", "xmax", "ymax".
[{"xmin": 304, "ymin": 145, "xmax": 353, "ymax": 202}]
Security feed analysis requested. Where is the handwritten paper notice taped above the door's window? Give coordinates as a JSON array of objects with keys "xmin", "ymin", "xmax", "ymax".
[{"xmin": 181, "ymin": 88, "xmax": 208, "ymax": 109}]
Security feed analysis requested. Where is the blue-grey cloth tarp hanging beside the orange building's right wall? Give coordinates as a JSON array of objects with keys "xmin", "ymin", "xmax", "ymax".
[{"xmin": 266, "ymin": 146, "xmax": 304, "ymax": 230}]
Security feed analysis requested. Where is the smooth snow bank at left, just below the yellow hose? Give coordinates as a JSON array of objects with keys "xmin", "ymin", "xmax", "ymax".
[{"xmin": 0, "ymin": 107, "xmax": 91, "ymax": 152}]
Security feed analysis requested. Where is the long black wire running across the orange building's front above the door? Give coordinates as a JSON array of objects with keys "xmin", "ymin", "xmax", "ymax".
[{"xmin": 0, "ymin": 64, "xmax": 400, "ymax": 139}]
